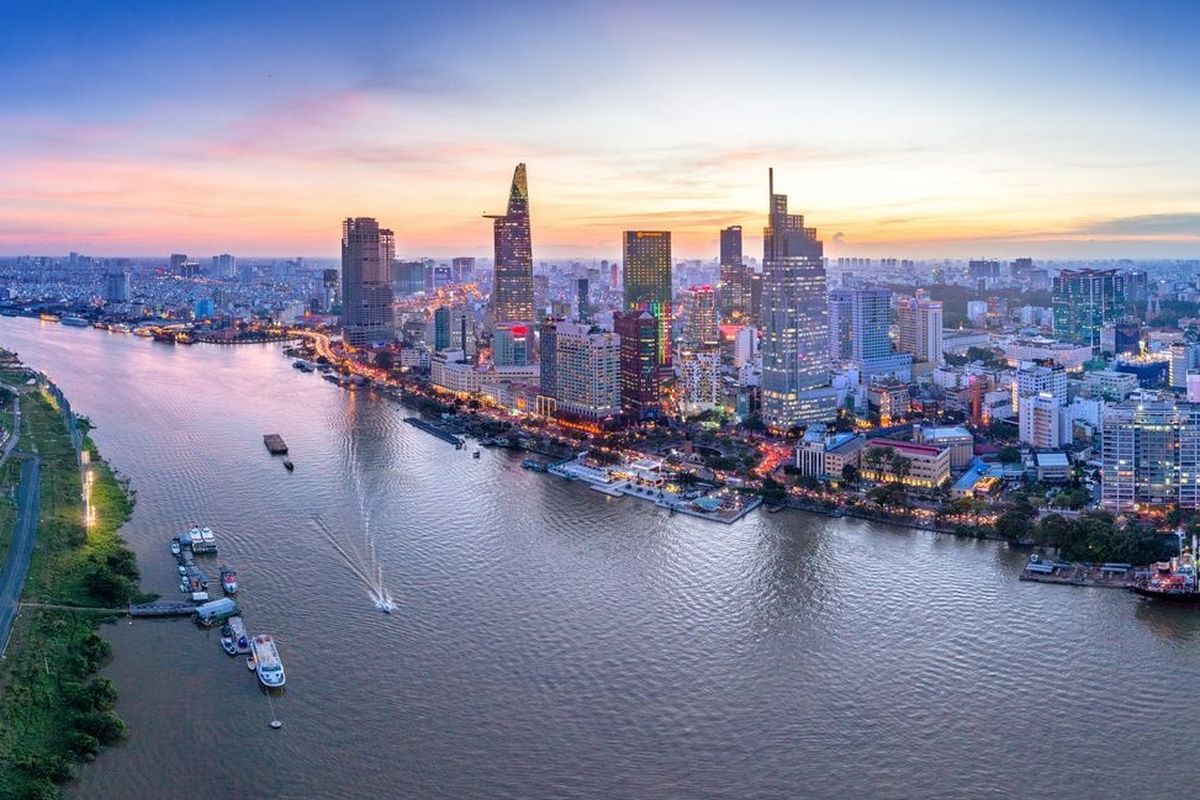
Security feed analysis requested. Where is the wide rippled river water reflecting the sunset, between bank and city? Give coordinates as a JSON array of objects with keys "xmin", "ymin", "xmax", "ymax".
[{"xmin": 0, "ymin": 318, "xmax": 1200, "ymax": 800}]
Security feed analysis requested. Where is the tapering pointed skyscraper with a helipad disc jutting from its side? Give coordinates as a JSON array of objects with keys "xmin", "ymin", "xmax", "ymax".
[{"xmin": 486, "ymin": 163, "xmax": 534, "ymax": 323}]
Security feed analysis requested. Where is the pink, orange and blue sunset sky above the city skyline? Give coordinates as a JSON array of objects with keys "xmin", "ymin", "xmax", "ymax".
[{"xmin": 0, "ymin": 0, "xmax": 1200, "ymax": 259}]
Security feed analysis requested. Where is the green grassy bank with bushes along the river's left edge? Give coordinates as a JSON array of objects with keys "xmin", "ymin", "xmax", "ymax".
[{"xmin": 0, "ymin": 391, "xmax": 138, "ymax": 800}]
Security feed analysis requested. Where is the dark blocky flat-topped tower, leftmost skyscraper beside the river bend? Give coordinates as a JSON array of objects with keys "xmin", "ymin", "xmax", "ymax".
[{"xmin": 342, "ymin": 217, "xmax": 396, "ymax": 347}]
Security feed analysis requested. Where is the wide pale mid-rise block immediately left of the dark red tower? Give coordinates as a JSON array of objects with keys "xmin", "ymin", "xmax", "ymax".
[{"xmin": 554, "ymin": 323, "xmax": 620, "ymax": 420}]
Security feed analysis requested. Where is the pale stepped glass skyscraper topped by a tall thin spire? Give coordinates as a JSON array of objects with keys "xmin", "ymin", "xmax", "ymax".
[{"xmin": 761, "ymin": 170, "xmax": 838, "ymax": 431}]
